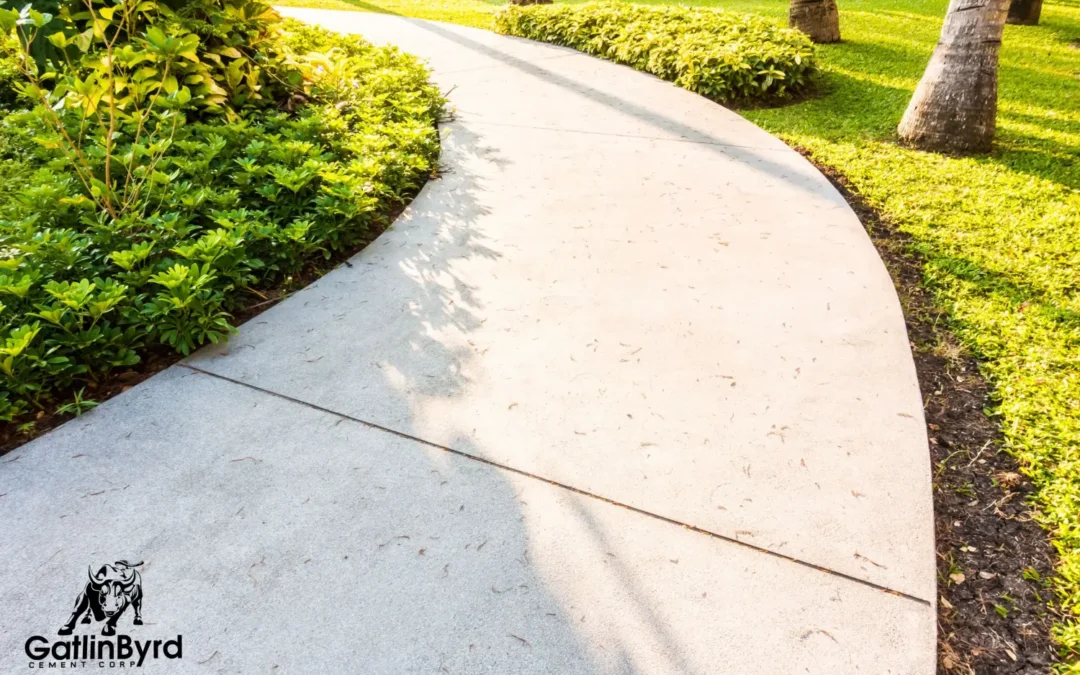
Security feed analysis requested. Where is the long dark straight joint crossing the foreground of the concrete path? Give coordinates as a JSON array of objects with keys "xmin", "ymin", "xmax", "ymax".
[{"xmin": 177, "ymin": 363, "xmax": 933, "ymax": 607}]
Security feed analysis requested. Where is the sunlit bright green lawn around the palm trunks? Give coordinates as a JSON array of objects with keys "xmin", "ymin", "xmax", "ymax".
[{"xmin": 272, "ymin": 0, "xmax": 1080, "ymax": 675}]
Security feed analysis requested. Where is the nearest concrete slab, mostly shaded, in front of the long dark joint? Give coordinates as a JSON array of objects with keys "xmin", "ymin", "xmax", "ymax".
[{"xmin": 0, "ymin": 367, "xmax": 934, "ymax": 675}]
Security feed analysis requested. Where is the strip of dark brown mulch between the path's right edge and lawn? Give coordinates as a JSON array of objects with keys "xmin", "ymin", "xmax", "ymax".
[{"xmin": 800, "ymin": 150, "xmax": 1056, "ymax": 675}]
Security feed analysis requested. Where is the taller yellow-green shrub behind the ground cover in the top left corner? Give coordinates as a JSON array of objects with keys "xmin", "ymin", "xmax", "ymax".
[{"xmin": 0, "ymin": 0, "xmax": 298, "ymax": 113}]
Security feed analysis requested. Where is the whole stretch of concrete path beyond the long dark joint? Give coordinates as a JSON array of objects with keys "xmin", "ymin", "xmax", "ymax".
[{"xmin": 190, "ymin": 11, "xmax": 935, "ymax": 600}]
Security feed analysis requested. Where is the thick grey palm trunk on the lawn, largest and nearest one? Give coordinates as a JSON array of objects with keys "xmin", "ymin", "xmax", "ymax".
[{"xmin": 899, "ymin": 0, "xmax": 1010, "ymax": 152}]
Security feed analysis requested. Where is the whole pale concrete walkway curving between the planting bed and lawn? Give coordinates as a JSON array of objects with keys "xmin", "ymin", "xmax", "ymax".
[{"xmin": 0, "ymin": 10, "xmax": 935, "ymax": 675}]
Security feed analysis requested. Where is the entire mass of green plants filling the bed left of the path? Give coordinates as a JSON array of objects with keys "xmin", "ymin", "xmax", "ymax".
[{"xmin": 0, "ymin": 0, "xmax": 443, "ymax": 421}]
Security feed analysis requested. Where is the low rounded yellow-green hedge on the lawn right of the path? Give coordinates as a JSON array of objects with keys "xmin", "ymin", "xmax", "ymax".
[{"xmin": 495, "ymin": 2, "xmax": 814, "ymax": 102}]
